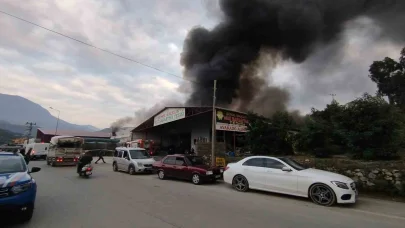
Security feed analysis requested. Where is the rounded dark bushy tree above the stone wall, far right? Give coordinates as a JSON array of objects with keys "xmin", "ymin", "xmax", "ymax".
[{"xmin": 339, "ymin": 93, "xmax": 405, "ymax": 159}]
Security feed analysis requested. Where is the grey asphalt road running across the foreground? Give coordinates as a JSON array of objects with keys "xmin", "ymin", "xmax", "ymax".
[{"xmin": 5, "ymin": 161, "xmax": 405, "ymax": 228}]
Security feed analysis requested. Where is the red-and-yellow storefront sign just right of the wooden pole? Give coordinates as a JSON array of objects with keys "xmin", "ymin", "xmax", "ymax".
[{"xmin": 216, "ymin": 109, "xmax": 249, "ymax": 132}]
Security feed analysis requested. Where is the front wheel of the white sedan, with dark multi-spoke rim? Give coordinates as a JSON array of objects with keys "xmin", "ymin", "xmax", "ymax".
[{"xmin": 309, "ymin": 184, "xmax": 336, "ymax": 207}]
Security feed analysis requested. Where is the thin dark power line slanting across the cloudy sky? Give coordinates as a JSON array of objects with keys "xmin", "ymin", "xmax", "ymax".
[{"xmin": 0, "ymin": 10, "xmax": 200, "ymax": 84}]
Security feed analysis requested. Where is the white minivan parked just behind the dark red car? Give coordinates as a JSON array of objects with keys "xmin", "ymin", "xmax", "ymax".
[{"xmin": 113, "ymin": 147, "xmax": 155, "ymax": 175}]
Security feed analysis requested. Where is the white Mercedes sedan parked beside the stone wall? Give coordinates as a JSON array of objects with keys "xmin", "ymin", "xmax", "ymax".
[{"xmin": 224, "ymin": 156, "xmax": 358, "ymax": 206}]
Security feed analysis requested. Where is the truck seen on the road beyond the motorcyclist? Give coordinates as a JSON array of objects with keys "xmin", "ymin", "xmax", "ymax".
[{"xmin": 46, "ymin": 136, "xmax": 84, "ymax": 166}]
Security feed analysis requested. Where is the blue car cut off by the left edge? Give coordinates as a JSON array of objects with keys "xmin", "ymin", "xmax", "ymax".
[{"xmin": 0, "ymin": 152, "xmax": 41, "ymax": 222}]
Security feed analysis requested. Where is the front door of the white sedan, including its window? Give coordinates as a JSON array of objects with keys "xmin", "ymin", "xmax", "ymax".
[{"xmin": 264, "ymin": 158, "xmax": 298, "ymax": 195}]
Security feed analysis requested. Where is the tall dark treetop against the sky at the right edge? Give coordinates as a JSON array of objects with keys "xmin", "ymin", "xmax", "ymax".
[{"xmin": 369, "ymin": 48, "xmax": 405, "ymax": 109}]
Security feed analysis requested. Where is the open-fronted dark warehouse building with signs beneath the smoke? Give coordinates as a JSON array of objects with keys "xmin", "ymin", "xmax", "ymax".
[{"xmin": 131, "ymin": 107, "xmax": 249, "ymax": 155}]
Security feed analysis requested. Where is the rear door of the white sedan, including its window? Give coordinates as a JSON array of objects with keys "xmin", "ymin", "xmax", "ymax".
[{"xmin": 242, "ymin": 158, "xmax": 267, "ymax": 190}]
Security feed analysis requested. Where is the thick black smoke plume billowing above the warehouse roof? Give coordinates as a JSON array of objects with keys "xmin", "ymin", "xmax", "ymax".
[{"xmin": 181, "ymin": 0, "xmax": 405, "ymax": 114}]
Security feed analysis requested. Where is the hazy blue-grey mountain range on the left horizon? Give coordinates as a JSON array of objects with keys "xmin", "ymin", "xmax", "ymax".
[{"xmin": 0, "ymin": 93, "xmax": 100, "ymax": 134}]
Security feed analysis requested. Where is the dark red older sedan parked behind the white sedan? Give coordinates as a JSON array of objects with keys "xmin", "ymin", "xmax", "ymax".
[{"xmin": 153, "ymin": 154, "xmax": 224, "ymax": 185}]
